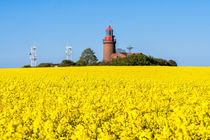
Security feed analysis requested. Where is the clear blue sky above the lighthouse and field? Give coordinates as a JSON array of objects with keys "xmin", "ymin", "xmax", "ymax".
[{"xmin": 0, "ymin": 0, "xmax": 210, "ymax": 68}]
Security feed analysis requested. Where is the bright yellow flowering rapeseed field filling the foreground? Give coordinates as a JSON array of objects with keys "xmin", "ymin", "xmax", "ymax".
[{"xmin": 0, "ymin": 66, "xmax": 210, "ymax": 140}]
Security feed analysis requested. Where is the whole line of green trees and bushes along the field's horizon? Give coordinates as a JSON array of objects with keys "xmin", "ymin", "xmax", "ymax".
[{"xmin": 24, "ymin": 48, "xmax": 177, "ymax": 68}]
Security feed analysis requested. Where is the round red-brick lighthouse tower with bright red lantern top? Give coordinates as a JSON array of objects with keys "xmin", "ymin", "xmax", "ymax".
[{"xmin": 103, "ymin": 25, "xmax": 116, "ymax": 62}]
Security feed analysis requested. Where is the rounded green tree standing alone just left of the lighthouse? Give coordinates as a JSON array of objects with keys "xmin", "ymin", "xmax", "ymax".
[{"xmin": 77, "ymin": 48, "xmax": 98, "ymax": 65}]
